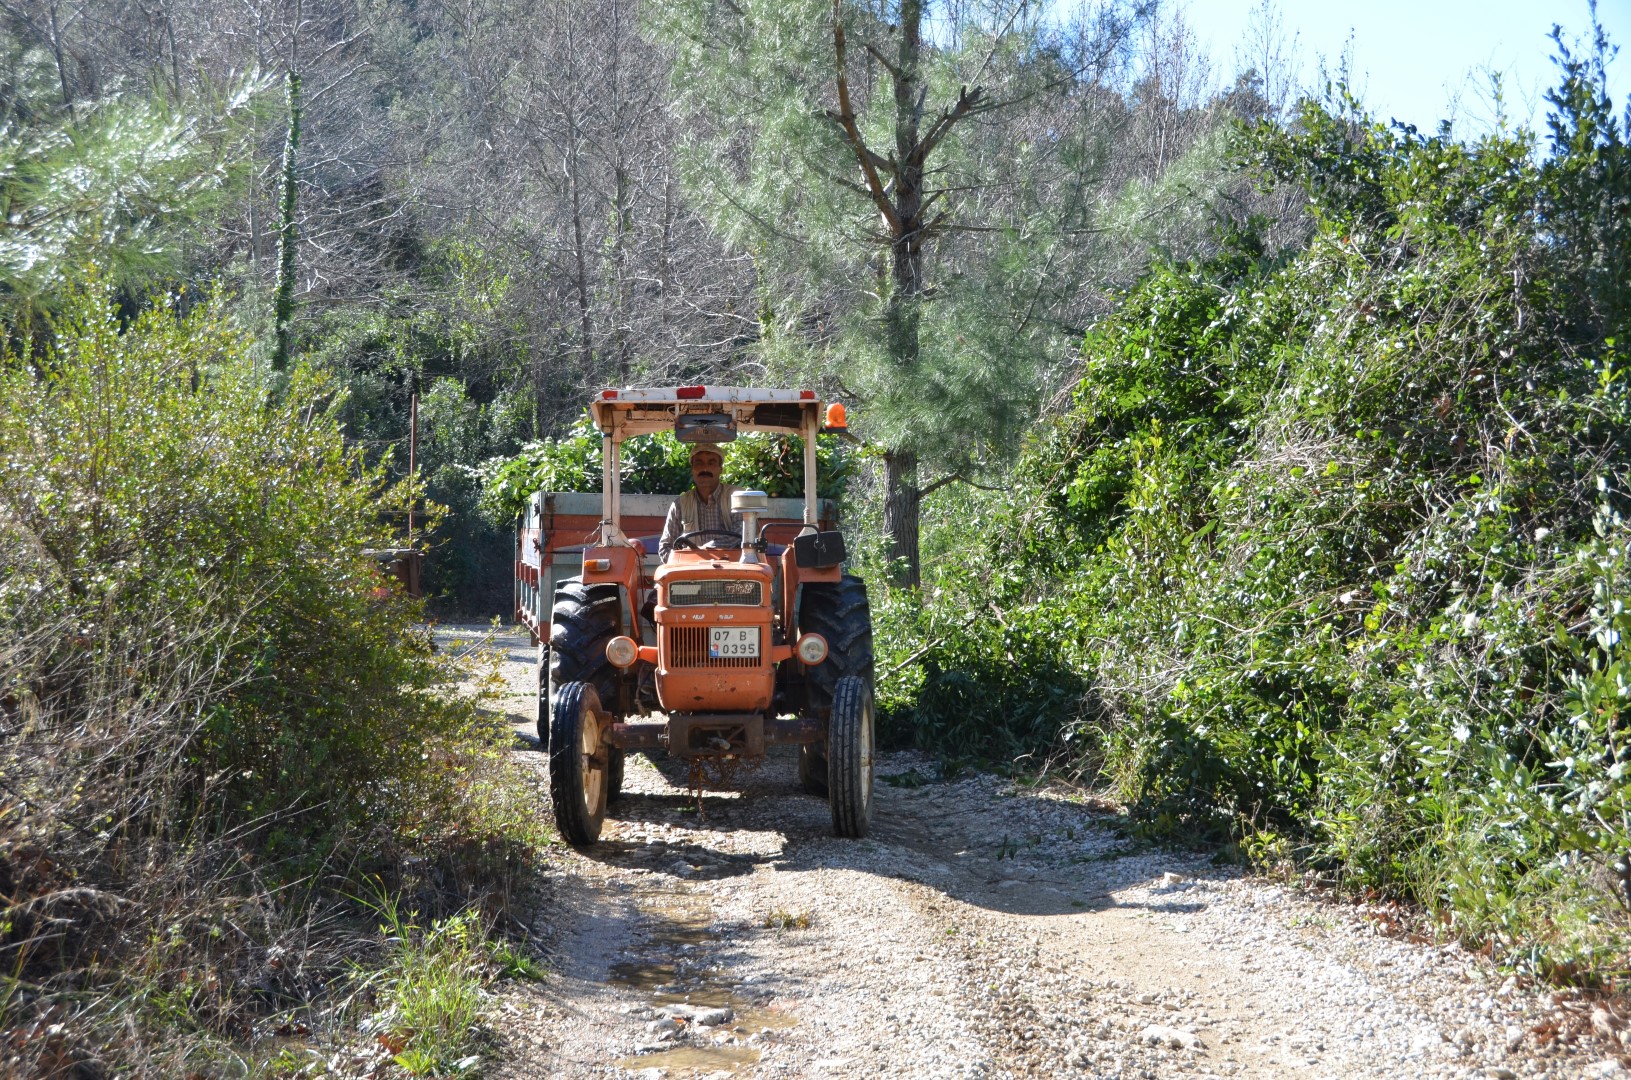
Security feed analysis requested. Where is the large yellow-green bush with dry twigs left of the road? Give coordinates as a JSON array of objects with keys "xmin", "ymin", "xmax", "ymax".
[{"xmin": 0, "ymin": 283, "xmax": 537, "ymax": 1075}]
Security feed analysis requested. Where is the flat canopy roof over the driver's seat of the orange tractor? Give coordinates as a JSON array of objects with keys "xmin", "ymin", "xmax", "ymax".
[{"xmin": 589, "ymin": 387, "xmax": 824, "ymax": 442}]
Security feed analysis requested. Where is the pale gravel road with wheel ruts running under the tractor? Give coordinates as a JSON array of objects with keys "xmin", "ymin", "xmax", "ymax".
[{"xmin": 442, "ymin": 630, "xmax": 1631, "ymax": 1080}]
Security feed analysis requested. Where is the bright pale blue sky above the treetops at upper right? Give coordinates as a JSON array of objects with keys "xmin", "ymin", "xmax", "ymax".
[{"xmin": 1168, "ymin": 0, "xmax": 1631, "ymax": 134}]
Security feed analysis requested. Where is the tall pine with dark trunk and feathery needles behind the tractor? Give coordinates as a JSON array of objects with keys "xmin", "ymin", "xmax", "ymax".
[{"xmin": 659, "ymin": 0, "xmax": 1145, "ymax": 584}]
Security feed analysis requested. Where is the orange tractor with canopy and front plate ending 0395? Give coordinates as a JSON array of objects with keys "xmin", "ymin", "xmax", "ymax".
[{"xmin": 515, "ymin": 387, "xmax": 873, "ymax": 845}]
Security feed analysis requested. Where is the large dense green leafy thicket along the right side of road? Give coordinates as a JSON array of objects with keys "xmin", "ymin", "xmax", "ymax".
[{"xmin": 879, "ymin": 48, "xmax": 1631, "ymax": 982}]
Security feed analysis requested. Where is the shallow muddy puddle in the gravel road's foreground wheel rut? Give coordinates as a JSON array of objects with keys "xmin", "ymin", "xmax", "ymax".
[{"xmin": 607, "ymin": 894, "xmax": 799, "ymax": 1075}]
